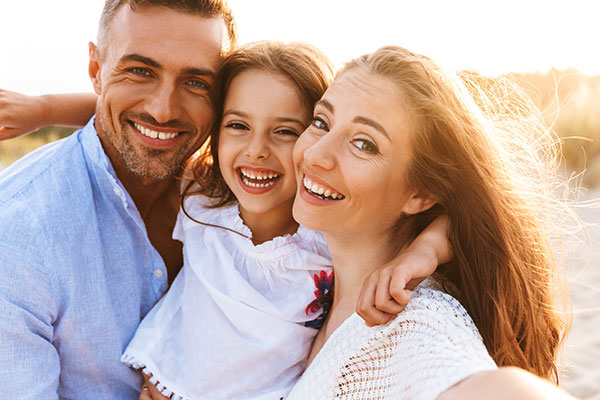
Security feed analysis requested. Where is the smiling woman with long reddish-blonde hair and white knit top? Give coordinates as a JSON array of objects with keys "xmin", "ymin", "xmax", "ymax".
[{"xmin": 289, "ymin": 47, "xmax": 565, "ymax": 400}]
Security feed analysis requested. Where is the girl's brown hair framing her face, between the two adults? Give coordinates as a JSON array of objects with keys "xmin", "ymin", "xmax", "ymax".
[{"xmin": 192, "ymin": 41, "xmax": 333, "ymax": 207}]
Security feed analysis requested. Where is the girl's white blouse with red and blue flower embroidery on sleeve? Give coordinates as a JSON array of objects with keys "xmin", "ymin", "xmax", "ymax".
[{"xmin": 122, "ymin": 196, "xmax": 332, "ymax": 400}]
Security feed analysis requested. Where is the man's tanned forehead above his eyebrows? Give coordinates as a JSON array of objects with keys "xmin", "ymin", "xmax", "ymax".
[{"xmin": 107, "ymin": 5, "xmax": 227, "ymax": 62}]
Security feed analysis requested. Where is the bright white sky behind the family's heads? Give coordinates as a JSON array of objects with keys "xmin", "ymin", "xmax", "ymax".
[{"xmin": 0, "ymin": 0, "xmax": 600, "ymax": 94}]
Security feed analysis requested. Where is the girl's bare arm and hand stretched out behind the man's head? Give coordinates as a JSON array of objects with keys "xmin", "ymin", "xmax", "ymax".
[{"xmin": 0, "ymin": 89, "xmax": 98, "ymax": 140}]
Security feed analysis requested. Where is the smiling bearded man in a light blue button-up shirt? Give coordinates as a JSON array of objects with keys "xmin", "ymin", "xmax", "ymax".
[{"xmin": 0, "ymin": 0, "xmax": 235, "ymax": 399}]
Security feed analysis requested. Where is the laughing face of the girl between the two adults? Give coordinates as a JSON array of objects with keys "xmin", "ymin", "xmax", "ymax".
[{"xmin": 218, "ymin": 70, "xmax": 310, "ymax": 227}]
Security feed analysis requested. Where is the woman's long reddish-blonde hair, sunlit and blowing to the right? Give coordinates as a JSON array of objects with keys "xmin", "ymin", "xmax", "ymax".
[{"xmin": 340, "ymin": 46, "xmax": 567, "ymax": 380}]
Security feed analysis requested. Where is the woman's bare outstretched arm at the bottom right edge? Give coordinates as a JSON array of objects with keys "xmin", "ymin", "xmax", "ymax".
[{"xmin": 438, "ymin": 367, "xmax": 574, "ymax": 400}]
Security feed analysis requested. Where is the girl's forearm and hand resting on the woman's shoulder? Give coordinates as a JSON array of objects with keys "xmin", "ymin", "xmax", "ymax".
[{"xmin": 356, "ymin": 215, "xmax": 452, "ymax": 326}]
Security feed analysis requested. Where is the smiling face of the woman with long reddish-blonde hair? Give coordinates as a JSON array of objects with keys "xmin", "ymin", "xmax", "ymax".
[{"xmin": 293, "ymin": 68, "xmax": 420, "ymax": 238}]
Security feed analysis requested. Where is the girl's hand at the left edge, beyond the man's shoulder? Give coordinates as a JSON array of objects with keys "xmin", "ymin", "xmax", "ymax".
[{"xmin": 0, "ymin": 89, "xmax": 47, "ymax": 140}]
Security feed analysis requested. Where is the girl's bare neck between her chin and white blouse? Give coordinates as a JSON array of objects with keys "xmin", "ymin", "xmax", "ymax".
[{"xmin": 240, "ymin": 199, "xmax": 298, "ymax": 245}]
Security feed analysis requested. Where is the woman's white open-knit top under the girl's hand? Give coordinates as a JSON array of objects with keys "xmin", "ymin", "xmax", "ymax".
[{"xmin": 286, "ymin": 278, "xmax": 496, "ymax": 400}]
